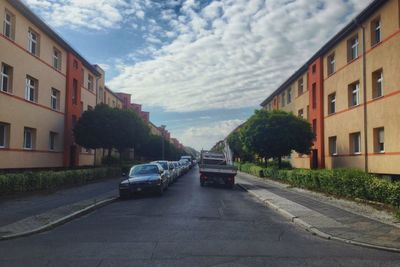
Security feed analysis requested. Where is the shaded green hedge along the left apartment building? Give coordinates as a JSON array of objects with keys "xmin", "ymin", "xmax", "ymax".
[{"xmin": 0, "ymin": 167, "xmax": 121, "ymax": 195}]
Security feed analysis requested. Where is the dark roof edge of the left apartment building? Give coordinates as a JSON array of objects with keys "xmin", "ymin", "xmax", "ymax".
[{"xmin": 7, "ymin": 0, "xmax": 101, "ymax": 77}]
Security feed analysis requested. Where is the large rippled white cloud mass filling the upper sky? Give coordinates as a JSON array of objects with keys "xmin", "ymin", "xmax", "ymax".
[{"xmin": 109, "ymin": 0, "xmax": 371, "ymax": 112}]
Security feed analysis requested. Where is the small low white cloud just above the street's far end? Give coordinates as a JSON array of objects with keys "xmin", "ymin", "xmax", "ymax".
[{"xmin": 177, "ymin": 120, "xmax": 243, "ymax": 151}]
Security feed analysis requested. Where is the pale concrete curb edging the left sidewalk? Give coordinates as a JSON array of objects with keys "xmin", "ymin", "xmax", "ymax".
[{"xmin": 0, "ymin": 197, "xmax": 118, "ymax": 241}]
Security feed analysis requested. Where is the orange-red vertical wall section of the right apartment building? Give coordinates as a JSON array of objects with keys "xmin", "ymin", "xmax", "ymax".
[{"xmin": 307, "ymin": 57, "xmax": 325, "ymax": 168}]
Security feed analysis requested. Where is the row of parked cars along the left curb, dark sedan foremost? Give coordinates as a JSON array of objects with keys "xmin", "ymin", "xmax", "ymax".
[{"xmin": 119, "ymin": 156, "xmax": 196, "ymax": 198}]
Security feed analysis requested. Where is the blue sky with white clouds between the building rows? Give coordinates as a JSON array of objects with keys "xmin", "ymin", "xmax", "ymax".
[{"xmin": 24, "ymin": 0, "xmax": 371, "ymax": 150}]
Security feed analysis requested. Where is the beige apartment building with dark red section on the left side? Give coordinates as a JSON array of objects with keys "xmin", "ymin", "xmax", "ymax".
[{"xmin": 0, "ymin": 0, "xmax": 100, "ymax": 169}]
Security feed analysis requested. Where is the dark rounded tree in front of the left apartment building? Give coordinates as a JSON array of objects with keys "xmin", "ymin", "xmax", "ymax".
[{"xmin": 74, "ymin": 104, "xmax": 149, "ymax": 160}]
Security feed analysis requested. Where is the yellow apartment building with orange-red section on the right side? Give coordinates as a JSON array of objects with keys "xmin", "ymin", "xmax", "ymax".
[{"xmin": 261, "ymin": 0, "xmax": 400, "ymax": 176}]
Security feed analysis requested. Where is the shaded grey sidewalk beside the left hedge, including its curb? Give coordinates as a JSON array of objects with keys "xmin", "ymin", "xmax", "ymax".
[{"xmin": 0, "ymin": 179, "xmax": 119, "ymax": 240}]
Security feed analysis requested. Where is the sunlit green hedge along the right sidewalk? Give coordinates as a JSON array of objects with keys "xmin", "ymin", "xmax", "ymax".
[{"xmin": 238, "ymin": 163, "xmax": 400, "ymax": 208}]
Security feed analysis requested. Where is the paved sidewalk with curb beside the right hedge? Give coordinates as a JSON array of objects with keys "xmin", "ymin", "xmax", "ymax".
[{"xmin": 236, "ymin": 172, "xmax": 400, "ymax": 252}]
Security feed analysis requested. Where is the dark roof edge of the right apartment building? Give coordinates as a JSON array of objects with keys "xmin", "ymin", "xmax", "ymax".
[{"xmin": 260, "ymin": 0, "xmax": 388, "ymax": 107}]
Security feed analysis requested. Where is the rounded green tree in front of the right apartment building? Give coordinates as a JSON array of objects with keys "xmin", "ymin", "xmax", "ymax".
[{"xmin": 241, "ymin": 110, "xmax": 315, "ymax": 167}]
